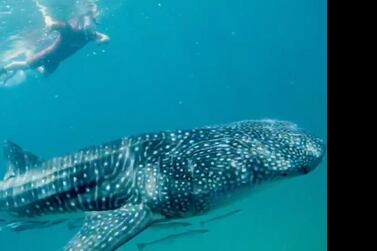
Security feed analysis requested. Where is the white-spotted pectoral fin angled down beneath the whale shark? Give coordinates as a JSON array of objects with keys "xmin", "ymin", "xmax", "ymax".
[{"xmin": 64, "ymin": 204, "xmax": 155, "ymax": 251}]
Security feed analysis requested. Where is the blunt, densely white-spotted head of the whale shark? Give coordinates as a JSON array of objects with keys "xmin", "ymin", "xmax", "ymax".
[{"xmin": 239, "ymin": 120, "xmax": 325, "ymax": 182}]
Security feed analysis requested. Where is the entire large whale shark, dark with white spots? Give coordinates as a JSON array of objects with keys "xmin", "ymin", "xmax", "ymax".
[{"xmin": 0, "ymin": 120, "xmax": 325, "ymax": 251}]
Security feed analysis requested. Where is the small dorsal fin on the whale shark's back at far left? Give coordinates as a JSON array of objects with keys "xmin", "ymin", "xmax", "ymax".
[{"xmin": 4, "ymin": 140, "xmax": 40, "ymax": 180}]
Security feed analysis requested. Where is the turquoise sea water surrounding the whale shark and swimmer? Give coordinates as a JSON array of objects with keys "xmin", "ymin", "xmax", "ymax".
[{"xmin": 0, "ymin": 0, "xmax": 327, "ymax": 251}]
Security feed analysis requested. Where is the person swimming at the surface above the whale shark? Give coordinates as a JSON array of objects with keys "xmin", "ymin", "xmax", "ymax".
[{"xmin": 0, "ymin": 8, "xmax": 110, "ymax": 83}]
